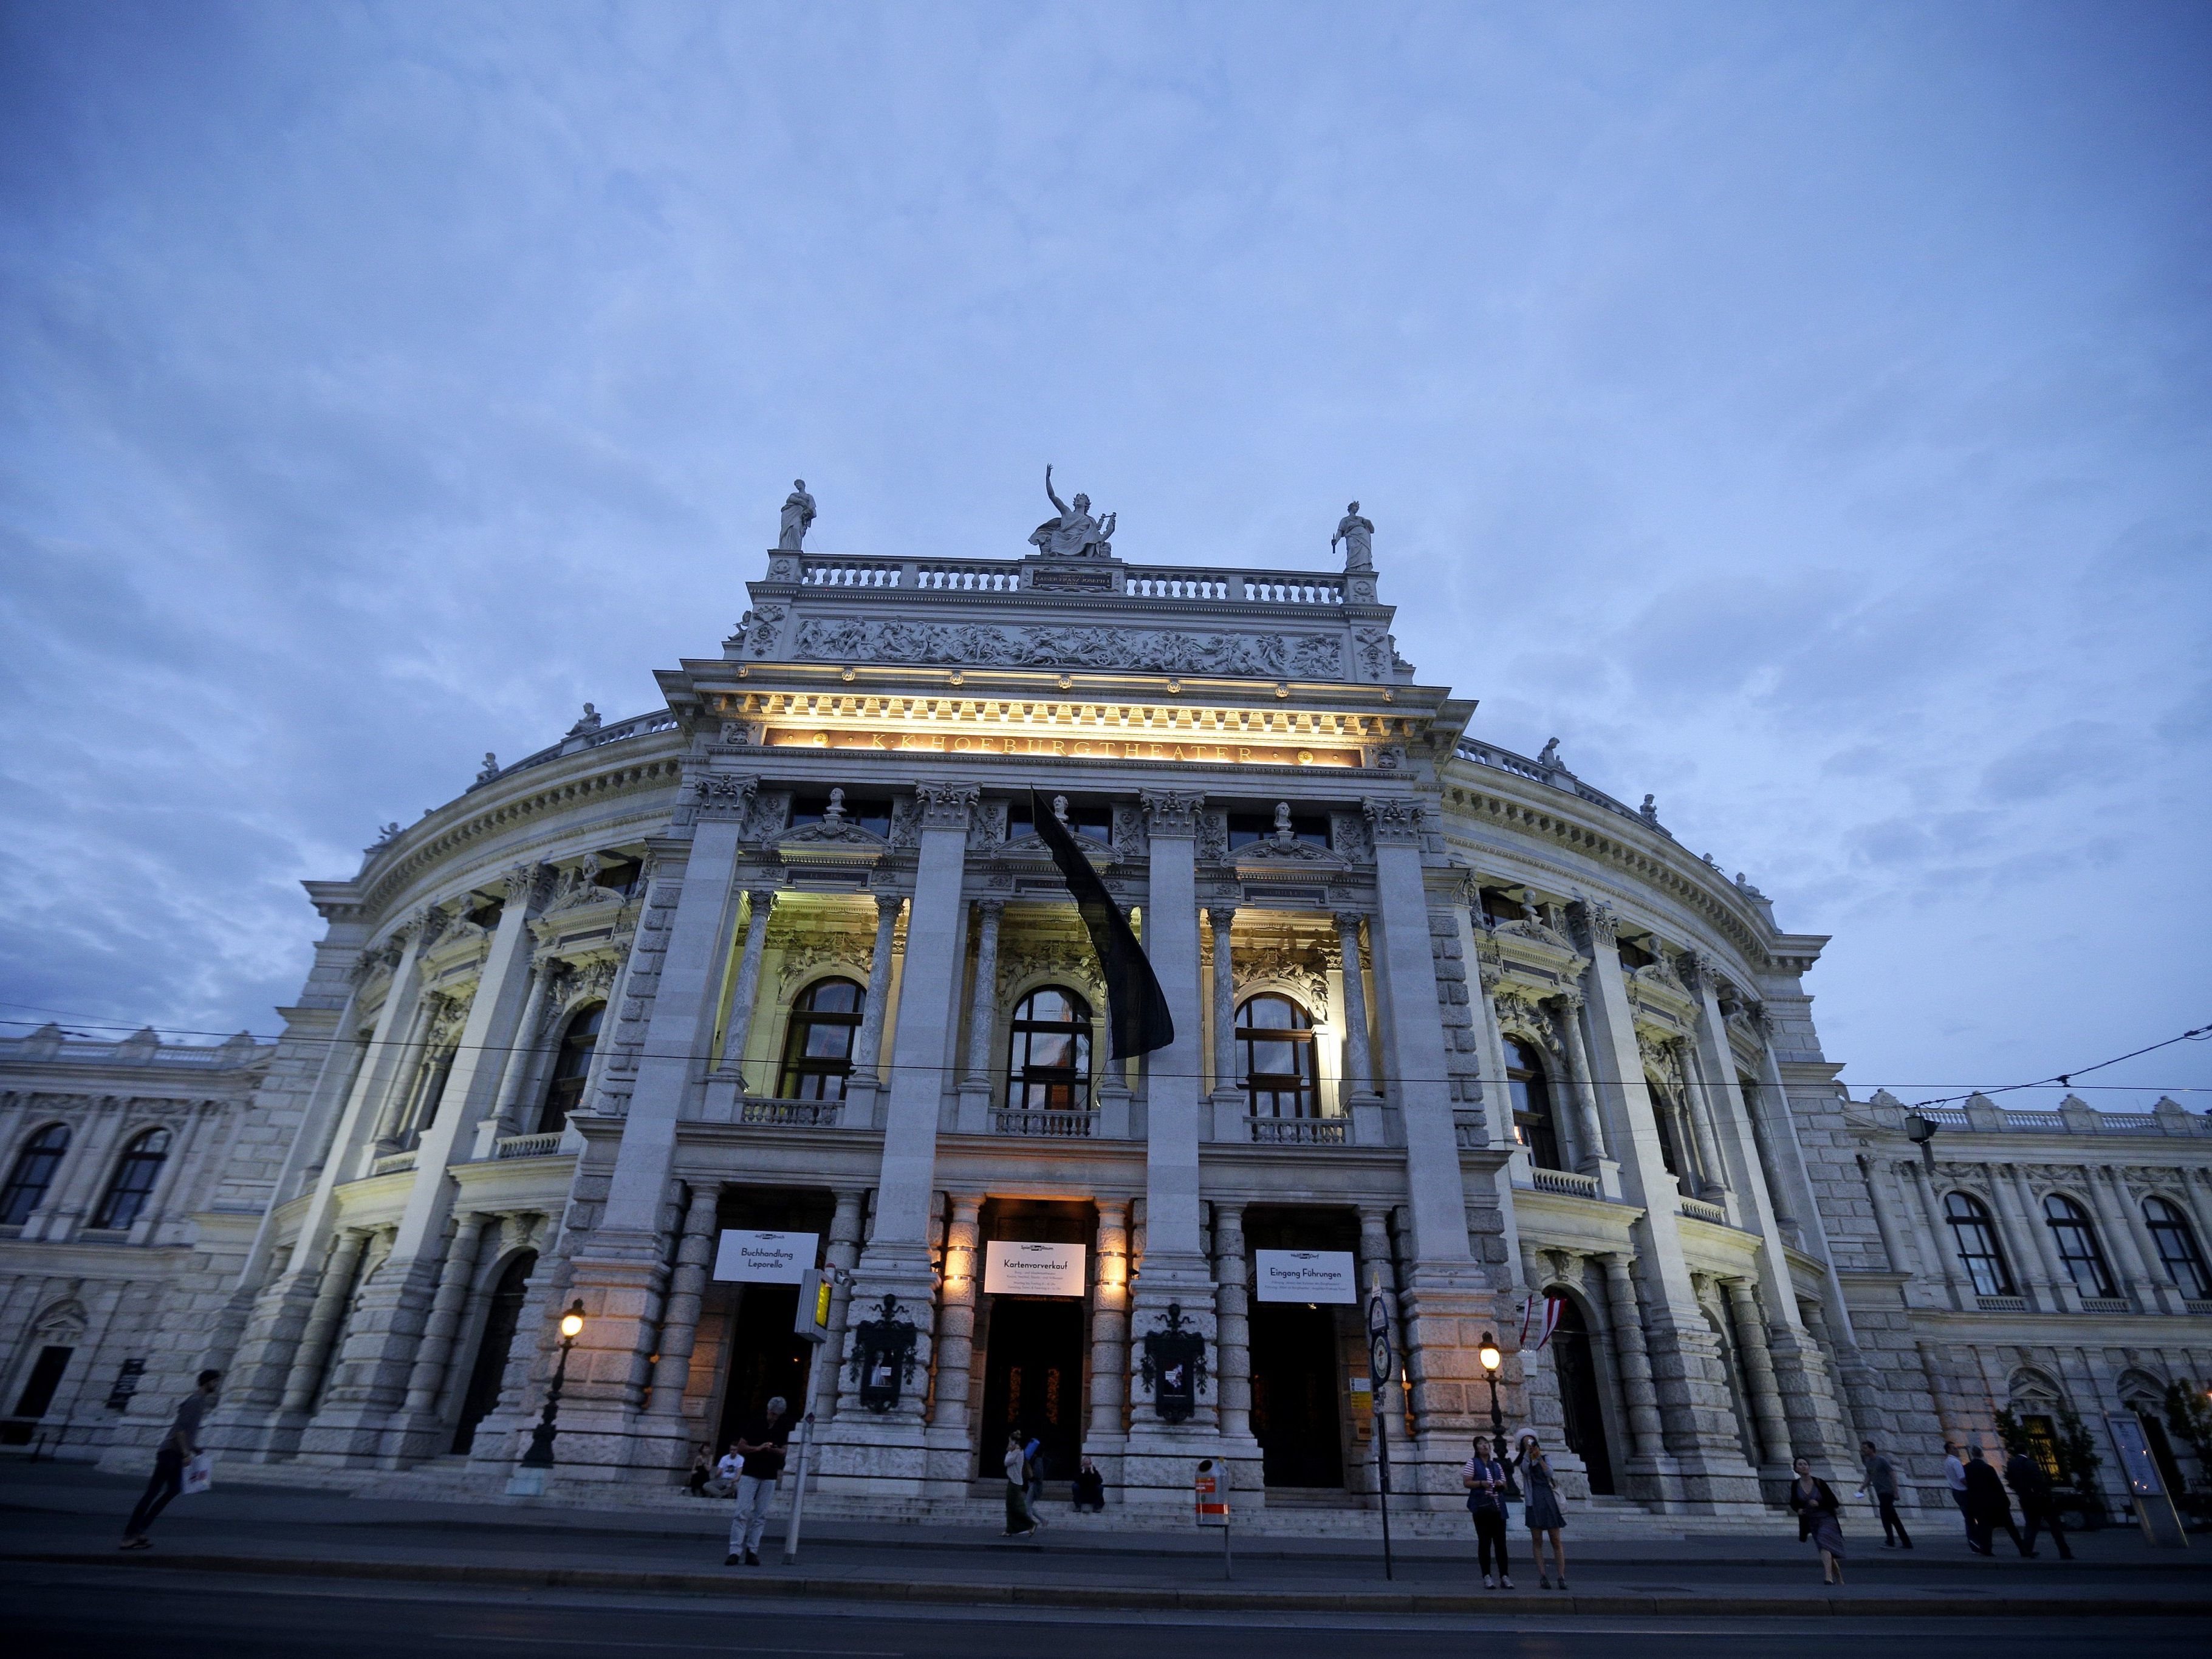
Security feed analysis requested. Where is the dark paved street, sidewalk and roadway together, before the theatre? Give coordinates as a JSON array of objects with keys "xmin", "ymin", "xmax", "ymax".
[{"xmin": 0, "ymin": 1465, "xmax": 2212, "ymax": 1659}]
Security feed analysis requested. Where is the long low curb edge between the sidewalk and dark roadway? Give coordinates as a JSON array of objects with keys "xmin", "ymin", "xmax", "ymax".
[{"xmin": 0, "ymin": 1553, "xmax": 2212, "ymax": 1619}]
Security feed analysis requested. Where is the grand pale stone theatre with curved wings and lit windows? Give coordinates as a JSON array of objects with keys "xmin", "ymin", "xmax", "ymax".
[{"xmin": 0, "ymin": 496, "xmax": 2212, "ymax": 1517}]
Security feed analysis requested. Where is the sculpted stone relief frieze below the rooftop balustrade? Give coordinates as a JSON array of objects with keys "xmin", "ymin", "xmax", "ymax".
[{"xmin": 792, "ymin": 617, "xmax": 1345, "ymax": 679}]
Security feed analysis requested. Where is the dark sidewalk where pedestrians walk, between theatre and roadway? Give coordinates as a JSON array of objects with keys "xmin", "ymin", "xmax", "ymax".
[{"xmin": 0, "ymin": 1465, "xmax": 2212, "ymax": 1617}]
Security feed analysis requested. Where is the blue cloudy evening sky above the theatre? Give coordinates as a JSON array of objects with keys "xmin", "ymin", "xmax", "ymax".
[{"xmin": 0, "ymin": 0, "xmax": 2212, "ymax": 1106}]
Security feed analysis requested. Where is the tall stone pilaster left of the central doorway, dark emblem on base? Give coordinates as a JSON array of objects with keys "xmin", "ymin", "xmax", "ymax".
[{"xmin": 821, "ymin": 783, "xmax": 982, "ymax": 1497}]
